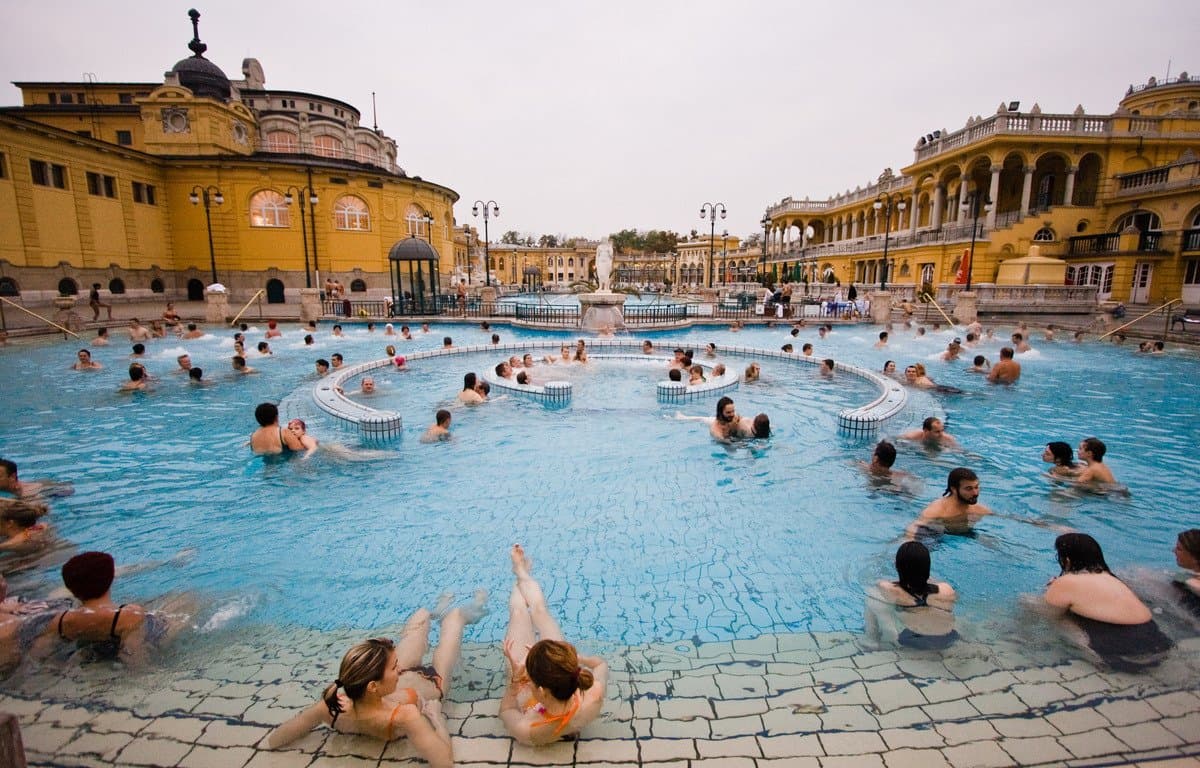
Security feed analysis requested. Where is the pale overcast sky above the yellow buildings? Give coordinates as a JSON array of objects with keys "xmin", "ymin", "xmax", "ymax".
[{"xmin": 0, "ymin": 0, "xmax": 1200, "ymax": 239}]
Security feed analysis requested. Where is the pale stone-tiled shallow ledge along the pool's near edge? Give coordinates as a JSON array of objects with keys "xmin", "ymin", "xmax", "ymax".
[{"xmin": 0, "ymin": 632, "xmax": 1200, "ymax": 768}]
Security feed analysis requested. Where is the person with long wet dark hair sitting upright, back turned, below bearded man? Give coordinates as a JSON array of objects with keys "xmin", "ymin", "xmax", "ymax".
[{"xmin": 866, "ymin": 541, "xmax": 959, "ymax": 650}]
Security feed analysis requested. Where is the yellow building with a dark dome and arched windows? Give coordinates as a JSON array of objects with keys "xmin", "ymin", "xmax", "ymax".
[{"xmin": 0, "ymin": 14, "xmax": 458, "ymax": 302}]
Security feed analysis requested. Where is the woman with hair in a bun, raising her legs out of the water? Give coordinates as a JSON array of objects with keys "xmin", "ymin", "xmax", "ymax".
[{"xmin": 500, "ymin": 544, "xmax": 608, "ymax": 746}]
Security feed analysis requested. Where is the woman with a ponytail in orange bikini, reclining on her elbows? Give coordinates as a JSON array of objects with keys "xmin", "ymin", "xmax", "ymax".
[{"xmin": 268, "ymin": 590, "xmax": 487, "ymax": 768}]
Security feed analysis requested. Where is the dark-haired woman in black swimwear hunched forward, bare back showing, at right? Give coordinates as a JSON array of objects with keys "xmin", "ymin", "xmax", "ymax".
[{"xmin": 1043, "ymin": 533, "xmax": 1171, "ymax": 672}]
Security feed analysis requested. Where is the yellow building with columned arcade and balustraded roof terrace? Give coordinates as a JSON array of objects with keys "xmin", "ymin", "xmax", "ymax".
[{"xmin": 762, "ymin": 73, "xmax": 1200, "ymax": 311}]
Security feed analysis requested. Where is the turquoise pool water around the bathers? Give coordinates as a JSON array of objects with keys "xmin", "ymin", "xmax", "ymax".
[{"xmin": 0, "ymin": 324, "xmax": 1200, "ymax": 644}]
